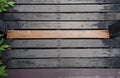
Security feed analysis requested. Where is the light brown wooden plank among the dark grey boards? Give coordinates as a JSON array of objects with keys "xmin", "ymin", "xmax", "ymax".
[{"xmin": 7, "ymin": 30, "xmax": 109, "ymax": 38}]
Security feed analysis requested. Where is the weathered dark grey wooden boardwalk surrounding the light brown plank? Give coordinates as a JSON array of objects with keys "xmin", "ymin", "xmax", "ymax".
[{"xmin": 2, "ymin": 0, "xmax": 120, "ymax": 78}]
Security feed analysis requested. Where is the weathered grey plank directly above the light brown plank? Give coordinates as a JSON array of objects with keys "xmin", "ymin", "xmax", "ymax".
[{"xmin": 6, "ymin": 21, "xmax": 115, "ymax": 29}]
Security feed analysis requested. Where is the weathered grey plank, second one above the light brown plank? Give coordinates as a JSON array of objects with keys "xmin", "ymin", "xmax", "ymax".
[{"xmin": 2, "ymin": 13, "xmax": 120, "ymax": 21}]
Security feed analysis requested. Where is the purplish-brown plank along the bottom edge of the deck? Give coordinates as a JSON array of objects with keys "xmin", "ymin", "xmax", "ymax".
[{"xmin": 7, "ymin": 68, "xmax": 120, "ymax": 78}]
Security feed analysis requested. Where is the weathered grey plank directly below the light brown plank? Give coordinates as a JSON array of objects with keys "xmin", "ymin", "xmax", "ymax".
[{"xmin": 6, "ymin": 39, "xmax": 120, "ymax": 48}]
